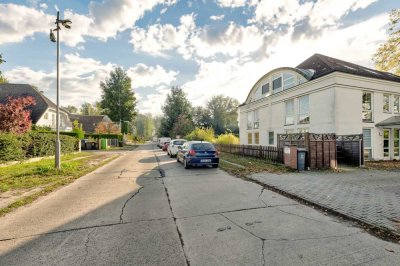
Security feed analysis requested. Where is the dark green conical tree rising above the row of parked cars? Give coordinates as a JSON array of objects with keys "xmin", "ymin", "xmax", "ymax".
[{"xmin": 159, "ymin": 87, "xmax": 192, "ymax": 138}]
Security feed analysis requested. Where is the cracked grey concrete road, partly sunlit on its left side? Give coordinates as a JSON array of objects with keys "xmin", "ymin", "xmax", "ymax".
[{"xmin": 0, "ymin": 145, "xmax": 400, "ymax": 265}]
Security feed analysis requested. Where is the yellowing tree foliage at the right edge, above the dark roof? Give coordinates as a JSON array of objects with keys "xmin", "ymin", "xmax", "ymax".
[{"xmin": 372, "ymin": 9, "xmax": 400, "ymax": 75}]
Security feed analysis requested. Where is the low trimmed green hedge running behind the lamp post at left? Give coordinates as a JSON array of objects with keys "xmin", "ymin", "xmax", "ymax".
[{"xmin": 0, "ymin": 131, "xmax": 79, "ymax": 162}]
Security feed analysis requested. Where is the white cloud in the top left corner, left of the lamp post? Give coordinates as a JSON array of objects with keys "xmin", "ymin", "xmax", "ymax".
[{"xmin": 0, "ymin": 4, "xmax": 55, "ymax": 44}]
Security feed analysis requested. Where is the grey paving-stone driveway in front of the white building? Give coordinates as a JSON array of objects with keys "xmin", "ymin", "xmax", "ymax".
[{"xmin": 252, "ymin": 169, "xmax": 400, "ymax": 235}]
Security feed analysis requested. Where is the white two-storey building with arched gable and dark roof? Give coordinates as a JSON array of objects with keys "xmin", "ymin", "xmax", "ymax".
[{"xmin": 239, "ymin": 54, "xmax": 400, "ymax": 160}]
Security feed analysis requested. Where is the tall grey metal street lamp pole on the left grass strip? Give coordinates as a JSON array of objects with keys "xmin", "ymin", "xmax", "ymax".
[{"xmin": 50, "ymin": 11, "xmax": 72, "ymax": 169}]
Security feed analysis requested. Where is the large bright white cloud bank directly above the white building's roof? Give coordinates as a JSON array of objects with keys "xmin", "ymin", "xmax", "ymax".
[{"xmin": 183, "ymin": 14, "xmax": 387, "ymax": 105}]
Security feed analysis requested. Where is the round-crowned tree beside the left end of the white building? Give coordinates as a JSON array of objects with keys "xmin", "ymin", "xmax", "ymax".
[{"xmin": 206, "ymin": 95, "xmax": 239, "ymax": 134}]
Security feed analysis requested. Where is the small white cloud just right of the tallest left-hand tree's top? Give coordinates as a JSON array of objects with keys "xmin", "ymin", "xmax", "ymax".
[{"xmin": 127, "ymin": 64, "xmax": 178, "ymax": 88}]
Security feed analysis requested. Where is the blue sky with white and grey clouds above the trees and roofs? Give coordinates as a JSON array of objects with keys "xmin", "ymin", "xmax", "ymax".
[{"xmin": 0, "ymin": 0, "xmax": 400, "ymax": 115}]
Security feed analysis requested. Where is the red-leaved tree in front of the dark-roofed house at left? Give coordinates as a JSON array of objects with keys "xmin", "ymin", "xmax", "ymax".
[{"xmin": 0, "ymin": 96, "xmax": 36, "ymax": 134}]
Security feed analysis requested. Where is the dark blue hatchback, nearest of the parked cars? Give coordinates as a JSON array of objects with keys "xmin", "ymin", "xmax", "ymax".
[{"xmin": 176, "ymin": 141, "xmax": 219, "ymax": 169}]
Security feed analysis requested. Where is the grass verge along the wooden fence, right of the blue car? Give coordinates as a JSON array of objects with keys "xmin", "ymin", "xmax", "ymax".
[{"xmin": 219, "ymin": 152, "xmax": 294, "ymax": 177}]
